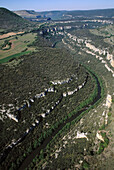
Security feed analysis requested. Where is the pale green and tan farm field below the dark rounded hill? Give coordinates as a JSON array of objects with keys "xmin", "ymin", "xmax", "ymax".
[{"xmin": 0, "ymin": 33, "xmax": 36, "ymax": 63}]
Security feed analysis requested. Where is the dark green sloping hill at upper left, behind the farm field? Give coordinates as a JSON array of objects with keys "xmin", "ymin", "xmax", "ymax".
[{"xmin": 0, "ymin": 8, "xmax": 32, "ymax": 31}]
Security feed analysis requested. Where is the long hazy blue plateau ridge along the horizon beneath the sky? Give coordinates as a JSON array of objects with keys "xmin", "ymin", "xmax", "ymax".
[{"xmin": 14, "ymin": 9, "xmax": 114, "ymax": 20}]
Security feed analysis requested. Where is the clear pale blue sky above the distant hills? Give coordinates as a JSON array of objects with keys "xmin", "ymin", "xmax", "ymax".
[{"xmin": 0, "ymin": 0, "xmax": 114, "ymax": 12}]
